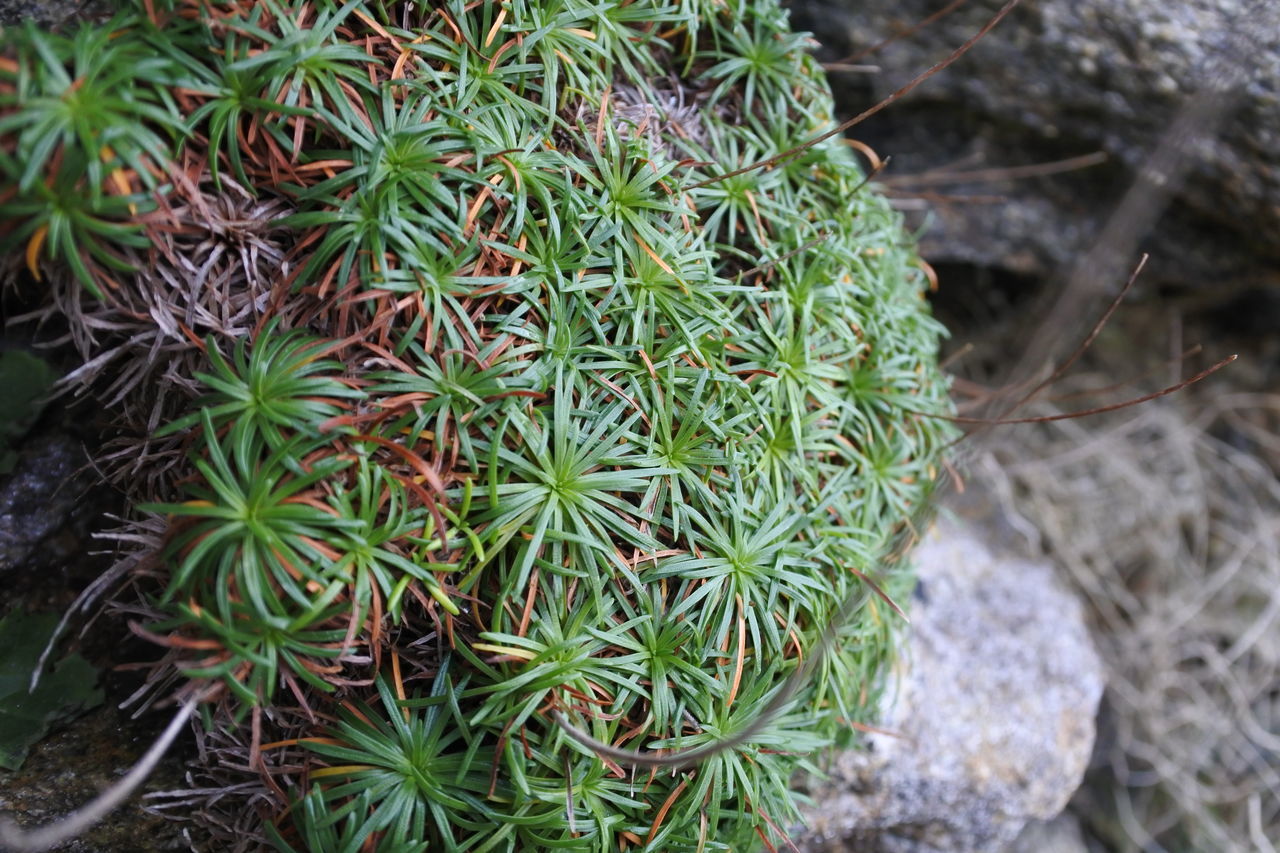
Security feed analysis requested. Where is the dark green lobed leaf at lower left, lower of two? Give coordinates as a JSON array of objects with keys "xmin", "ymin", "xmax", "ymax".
[{"xmin": 0, "ymin": 611, "xmax": 102, "ymax": 770}]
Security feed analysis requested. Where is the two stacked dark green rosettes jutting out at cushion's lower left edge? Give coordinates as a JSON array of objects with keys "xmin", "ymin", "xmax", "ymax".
[{"xmin": 145, "ymin": 409, "xmax": 360, "ymax": 704}]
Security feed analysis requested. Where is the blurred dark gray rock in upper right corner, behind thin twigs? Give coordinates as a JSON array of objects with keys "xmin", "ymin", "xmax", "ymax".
[{"xmin": 794, "ymin": 0, "xmax": 1280, "ymax": 295}]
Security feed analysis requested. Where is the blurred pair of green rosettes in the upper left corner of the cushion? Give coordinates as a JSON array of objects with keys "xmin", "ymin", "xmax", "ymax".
[{"xmin": 0, "ymin": 13, "xmax": 186, "ymax": 290}]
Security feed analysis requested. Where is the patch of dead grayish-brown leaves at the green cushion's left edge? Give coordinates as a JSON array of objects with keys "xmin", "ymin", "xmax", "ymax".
[{"xmin": 10, "ymin": 164, "xmax": 293, "ymax": 498}]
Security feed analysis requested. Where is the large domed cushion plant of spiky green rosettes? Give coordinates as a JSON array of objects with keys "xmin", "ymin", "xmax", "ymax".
[{"xmin": 0, "ymin": 0, "xmax": 948, "ymax": 852}]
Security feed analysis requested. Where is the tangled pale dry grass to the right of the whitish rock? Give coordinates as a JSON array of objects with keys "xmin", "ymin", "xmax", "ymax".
[{"xmin": 969, "ymin": 375, "xmax": 1280, "ymax": 853}]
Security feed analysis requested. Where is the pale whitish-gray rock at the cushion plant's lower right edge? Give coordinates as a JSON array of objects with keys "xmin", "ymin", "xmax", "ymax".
[{"xmin": 797, "ymin": 523, "xmax": 1103, "ymax": 853}]
